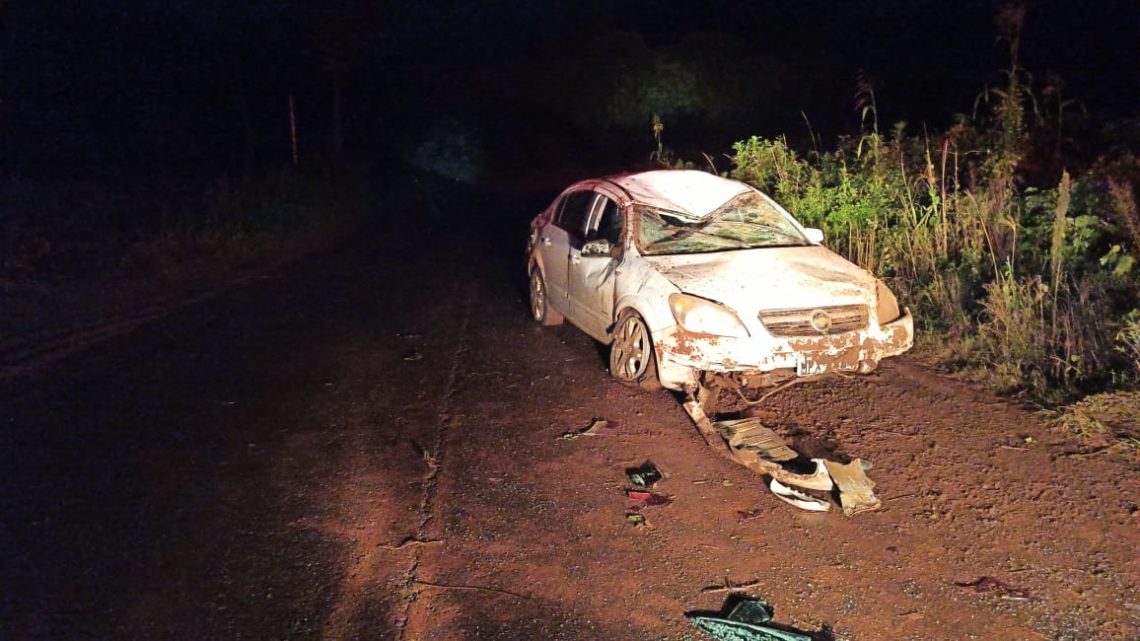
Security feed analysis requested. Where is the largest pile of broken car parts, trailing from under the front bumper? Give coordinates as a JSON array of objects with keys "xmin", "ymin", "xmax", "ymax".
[{"xmin": 684, "ymin": 395, "xmax": 882, "ymax": 517}]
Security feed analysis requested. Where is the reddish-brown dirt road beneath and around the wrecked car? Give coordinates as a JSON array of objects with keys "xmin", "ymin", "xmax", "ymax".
[{"xmin": 0, "ymin": 175, "xmax": 1140, "ymax": 641}]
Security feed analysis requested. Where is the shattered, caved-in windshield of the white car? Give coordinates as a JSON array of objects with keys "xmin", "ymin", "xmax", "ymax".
[{"xmin": 634, "ymin": 192, "xmax": 809, "ymax": 255}]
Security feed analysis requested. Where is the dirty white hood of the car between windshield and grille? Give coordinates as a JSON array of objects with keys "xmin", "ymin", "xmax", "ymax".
[{"xmin": 643, "ymin": 245, "xmax": 874, "ymax": 310}]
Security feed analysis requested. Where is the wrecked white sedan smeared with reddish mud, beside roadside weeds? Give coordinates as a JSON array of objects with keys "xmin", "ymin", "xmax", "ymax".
[{"xmin": 527, "ymin": 170, "xmax": 913, "ymax": 391}]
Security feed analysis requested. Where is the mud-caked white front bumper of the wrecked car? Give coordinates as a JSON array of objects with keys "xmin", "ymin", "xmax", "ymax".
[{"xmin": 654, "ymin": 309, "xmax": 914, "ymax": 390}]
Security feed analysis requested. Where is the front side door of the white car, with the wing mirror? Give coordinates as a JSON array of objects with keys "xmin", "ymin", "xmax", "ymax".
[{"xmin": 567, "ymin": 194, "xmax": 625, "ymax": 342}]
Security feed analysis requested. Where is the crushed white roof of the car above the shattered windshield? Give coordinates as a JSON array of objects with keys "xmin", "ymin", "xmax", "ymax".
[{"xmin": 606, "ymin": 169, "xmax": 749, "ymax": 218}]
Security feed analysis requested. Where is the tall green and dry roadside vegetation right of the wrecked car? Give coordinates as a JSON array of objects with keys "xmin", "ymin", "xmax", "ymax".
[{"xmin": 715, "ymin": 10, "xmax": 1140, "ymax": 437}]
